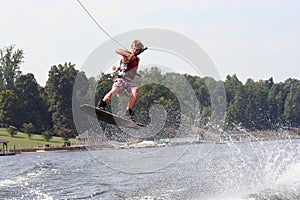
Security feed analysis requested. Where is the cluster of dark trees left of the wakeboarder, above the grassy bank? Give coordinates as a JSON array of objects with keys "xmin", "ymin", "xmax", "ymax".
[{"xmin": 0, "ymin": 45, "xmax": 78, "ymax": 140}]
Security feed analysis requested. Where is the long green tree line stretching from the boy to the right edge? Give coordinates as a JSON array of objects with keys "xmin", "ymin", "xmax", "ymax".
[{"xmin": 97, "ymin": 68, "xmax": 300, "ymax": 133}]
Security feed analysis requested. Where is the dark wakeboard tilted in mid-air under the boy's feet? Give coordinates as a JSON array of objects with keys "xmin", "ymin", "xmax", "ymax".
[{"xmin": 80, "ymin": 104, "xmax": 145, "ymax": 129}]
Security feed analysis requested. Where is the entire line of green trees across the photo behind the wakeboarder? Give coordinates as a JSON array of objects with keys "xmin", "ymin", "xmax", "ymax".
[{"xmin": 0, "ymin": 45, "xmax": 300, "ymax": 140}]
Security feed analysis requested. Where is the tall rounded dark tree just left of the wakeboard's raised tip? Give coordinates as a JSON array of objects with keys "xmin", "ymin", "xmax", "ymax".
[{"xmin": 45, "ymin": 63, "xmax": 78, "ymax": 140}]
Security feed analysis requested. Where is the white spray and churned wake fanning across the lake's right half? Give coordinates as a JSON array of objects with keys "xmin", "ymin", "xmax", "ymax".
[{"xmin": 128, "ymin": 140, "xmax": 300, "ymax": 200}]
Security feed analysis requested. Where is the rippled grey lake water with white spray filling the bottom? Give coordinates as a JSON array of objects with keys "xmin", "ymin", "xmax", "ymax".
[{"xmin": 0, "ymin": 140, "xmax": 300, "ymax": 200}]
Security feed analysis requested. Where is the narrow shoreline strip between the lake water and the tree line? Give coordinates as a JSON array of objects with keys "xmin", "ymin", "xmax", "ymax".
[{"xmin": 0, "ymin": 131, "xmax": 300, "ymax": 156}]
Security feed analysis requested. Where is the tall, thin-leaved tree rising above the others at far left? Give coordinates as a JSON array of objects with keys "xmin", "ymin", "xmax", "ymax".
[{"xmin": 0, "ymin": 45, "xmax": 24, "ymax": 90}]
